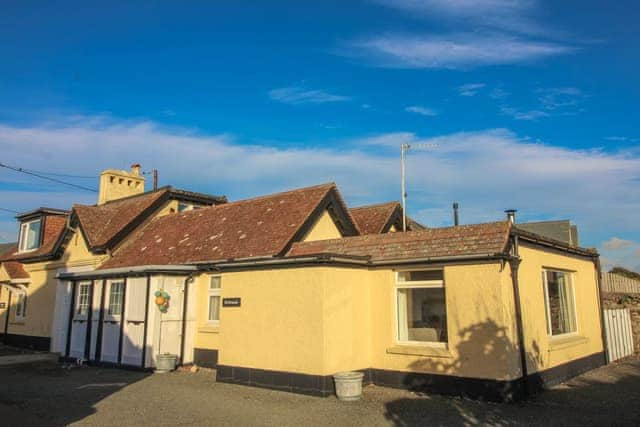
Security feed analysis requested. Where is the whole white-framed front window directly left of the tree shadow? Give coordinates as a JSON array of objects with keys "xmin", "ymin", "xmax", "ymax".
[{"xmin": 396, "ymin": 270, "xmax": 447, "ymax": 347}]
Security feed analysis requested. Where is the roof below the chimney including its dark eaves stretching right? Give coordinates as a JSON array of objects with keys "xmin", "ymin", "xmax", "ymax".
[{"xmin": 73, "ymin": 187, "xmax": 227, "ymax": 249}]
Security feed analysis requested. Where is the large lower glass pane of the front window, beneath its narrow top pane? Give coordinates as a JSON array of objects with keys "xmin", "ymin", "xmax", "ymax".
[{"xmin": 398, "ymin": 288, "xmax": 447, "ymax": 342}]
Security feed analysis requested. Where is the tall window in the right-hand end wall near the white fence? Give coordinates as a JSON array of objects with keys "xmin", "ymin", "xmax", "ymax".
[{"xmin": 542, "ymin": 270, "xmax": 577, "ymax": 336}]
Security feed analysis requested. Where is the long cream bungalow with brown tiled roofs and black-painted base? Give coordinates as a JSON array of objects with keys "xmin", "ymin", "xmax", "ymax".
[{"xmin": 50, "ymin": 184, "xmax": 605, "ymax": 400}]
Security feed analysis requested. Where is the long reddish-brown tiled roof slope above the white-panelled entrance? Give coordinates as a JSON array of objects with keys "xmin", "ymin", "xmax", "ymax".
[{"xmin": 101, "ymin": 184, "xmax": 342, "ymax": 269}]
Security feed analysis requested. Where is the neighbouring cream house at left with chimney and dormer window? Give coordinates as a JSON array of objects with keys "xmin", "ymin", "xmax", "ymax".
[{"xmin": 0, "ymin": 165, "xmax": 226, "ymax": 352}]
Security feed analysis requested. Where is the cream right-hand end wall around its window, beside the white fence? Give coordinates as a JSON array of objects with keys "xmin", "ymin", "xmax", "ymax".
[{"xmin": 518, "ymin": 244, "xmax": 603, "ymax": 372}]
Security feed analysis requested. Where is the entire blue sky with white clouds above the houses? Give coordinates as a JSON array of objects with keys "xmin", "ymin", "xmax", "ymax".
[{"xmin": 0, "ymin": 0, "xmax": 640, "ymax": 269}]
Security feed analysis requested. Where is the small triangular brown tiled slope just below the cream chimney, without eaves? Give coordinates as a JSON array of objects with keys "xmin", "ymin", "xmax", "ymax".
[{"xmin": 73, "ymin": 188, "xmax": 169, "ymax": 247}]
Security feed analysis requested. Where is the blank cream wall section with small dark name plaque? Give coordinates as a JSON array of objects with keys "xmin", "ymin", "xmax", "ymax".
[{"xmin": 215, "ymin": 268, "xmax": 324, "ymax": 375}]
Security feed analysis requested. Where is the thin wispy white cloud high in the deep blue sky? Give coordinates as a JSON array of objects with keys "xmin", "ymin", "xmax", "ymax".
[{"xmin": 346, "ymin": 33, "xmax": 575, "ymax": 69}]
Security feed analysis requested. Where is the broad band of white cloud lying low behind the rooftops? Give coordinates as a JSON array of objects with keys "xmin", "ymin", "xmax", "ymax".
[{"xmin": 0, "ymin": 117, "xmax": 640, "ymax": 265}]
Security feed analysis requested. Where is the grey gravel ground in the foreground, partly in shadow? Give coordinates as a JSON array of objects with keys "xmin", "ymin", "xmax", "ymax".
[{"xmin": 0, "ymin": 360, "xmax": 640, "ymax": 426}]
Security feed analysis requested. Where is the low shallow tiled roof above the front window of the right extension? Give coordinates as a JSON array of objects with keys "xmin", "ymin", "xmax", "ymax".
[{"xmin": 288, "ymin": 221, "xmax": 510, "ymax": 262}]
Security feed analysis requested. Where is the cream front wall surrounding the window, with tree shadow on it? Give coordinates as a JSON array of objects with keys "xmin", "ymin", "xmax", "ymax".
[{"xmin": 371, "ymin": 262, "xmax": 520, "ymax": 380}]
